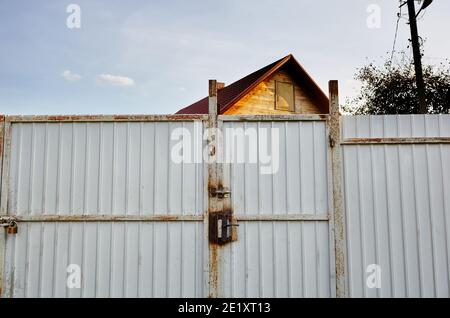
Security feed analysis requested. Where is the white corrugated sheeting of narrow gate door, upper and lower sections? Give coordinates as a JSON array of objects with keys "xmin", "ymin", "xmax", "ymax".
[{"xmin": 220, "ymin": 121, "xmax": 334, "ymax": 297}]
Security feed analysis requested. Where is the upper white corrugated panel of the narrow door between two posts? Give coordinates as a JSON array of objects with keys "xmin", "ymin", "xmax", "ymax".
[{"xmin": 224, "ymin": 121, "xmax": 329, "ymax": 215}]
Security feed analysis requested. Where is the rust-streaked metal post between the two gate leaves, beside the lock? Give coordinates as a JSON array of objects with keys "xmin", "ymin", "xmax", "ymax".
[{"xmin": 206, "ymin": 80, "xmax": 223, "ymax": 298}]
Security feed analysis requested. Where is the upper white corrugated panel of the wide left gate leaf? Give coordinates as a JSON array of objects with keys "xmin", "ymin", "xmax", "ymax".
[{"xmin": 9, "ymin": 122, "xmax": 204, "ymax": 215}]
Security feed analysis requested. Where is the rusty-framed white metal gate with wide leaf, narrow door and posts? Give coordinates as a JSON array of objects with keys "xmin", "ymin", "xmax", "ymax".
[{"xmin": 0, "ymin": 81, "xmax": 345, "ymax": 297}]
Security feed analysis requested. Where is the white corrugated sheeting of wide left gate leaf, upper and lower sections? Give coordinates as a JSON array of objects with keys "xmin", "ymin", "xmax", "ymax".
[{"xmin": 3, "ymin": 121, "xmax": 207, "ymax": 297}]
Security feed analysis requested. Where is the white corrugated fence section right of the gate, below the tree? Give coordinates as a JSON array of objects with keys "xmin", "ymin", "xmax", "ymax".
[{"xmin": 342, "ymin": 115, "xmax": 450, "ymax": 297}]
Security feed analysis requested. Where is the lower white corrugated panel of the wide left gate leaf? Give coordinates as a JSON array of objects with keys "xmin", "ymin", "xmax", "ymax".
[{"xmin": 4, "ymin": 222, "xmax": 205, "ymax": 298}]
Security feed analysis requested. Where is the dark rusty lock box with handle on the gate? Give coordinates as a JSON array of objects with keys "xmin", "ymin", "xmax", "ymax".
[{"xmin": 209, "ymin": 211, "xmax": 239, "ymax": 245}]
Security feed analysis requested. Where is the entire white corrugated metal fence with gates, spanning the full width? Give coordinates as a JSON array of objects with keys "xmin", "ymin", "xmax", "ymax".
[{"xmin": 0, "ymin": 115, "xmax": 450, "ymax": 298}]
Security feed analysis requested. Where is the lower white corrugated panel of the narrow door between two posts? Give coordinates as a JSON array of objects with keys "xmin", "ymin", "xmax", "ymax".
[{"xmin": 222, "ymin": 221, "xmax": 333, "ymax": 298}]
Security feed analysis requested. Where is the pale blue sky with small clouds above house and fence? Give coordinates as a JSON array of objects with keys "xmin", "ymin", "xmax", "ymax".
[{"xmin": 0, "ymin": 0, "xmax": 450, "ymax": 115}]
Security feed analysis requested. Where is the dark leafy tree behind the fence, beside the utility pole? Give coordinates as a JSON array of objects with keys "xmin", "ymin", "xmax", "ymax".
[{"xmin": 342, "ymin": 59, "xmax": 450, "ymax": 115}]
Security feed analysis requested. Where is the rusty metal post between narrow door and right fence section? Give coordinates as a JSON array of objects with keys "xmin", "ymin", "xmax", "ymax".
[{"xmin": 329, "ymin": 81, "xmax": 348, "ymax": 298}]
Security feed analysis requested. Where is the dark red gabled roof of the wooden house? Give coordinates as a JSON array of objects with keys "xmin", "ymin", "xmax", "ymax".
[{"xmin": 177, "ymin": 54, "xmax": 329, "ymax": 114}]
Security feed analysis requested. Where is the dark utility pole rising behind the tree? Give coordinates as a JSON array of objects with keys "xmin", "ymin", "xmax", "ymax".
[{"xmin": 407, "ymin": 0, "xmax": 428, "ymax": 114}]
